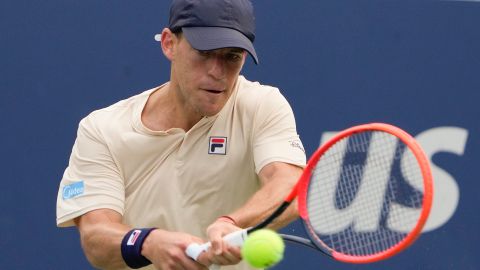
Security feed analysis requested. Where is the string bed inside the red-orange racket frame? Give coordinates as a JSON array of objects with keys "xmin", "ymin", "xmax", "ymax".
[{"xmin": 307, "ymin": 131, "xmax": 423, "ymax": 255}]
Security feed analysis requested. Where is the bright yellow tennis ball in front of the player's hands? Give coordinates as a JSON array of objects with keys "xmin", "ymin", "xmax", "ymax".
[{"xmin": 242, "ymin": 229, "xmax": 285, "ymax": 268}]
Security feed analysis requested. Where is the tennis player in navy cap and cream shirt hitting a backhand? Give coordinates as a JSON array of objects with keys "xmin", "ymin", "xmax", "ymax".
[{"xmin": 57, "ymin": 0, "xmax": 306, "ymax": 270}]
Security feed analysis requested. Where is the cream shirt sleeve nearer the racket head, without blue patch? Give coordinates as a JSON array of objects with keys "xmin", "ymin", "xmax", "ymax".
[{"xmin": 253, "ymin": 89, "xmax": 306, "ymax": 173}]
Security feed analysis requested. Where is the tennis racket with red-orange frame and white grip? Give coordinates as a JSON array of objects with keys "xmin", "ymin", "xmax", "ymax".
[{"xmin": 186, "ymin": 123, "xmax": 433, "ymax": 263}]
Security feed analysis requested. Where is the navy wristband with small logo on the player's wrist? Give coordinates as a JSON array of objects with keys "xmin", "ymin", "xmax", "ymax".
[{"xmin": 121, "ymin": 228, "xmax": 156, "ymax": 269}]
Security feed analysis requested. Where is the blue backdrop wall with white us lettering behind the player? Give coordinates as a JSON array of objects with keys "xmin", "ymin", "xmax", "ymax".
[{"xmin": 0, "ymin": 0, "xmax": 480, "ymax": 270}]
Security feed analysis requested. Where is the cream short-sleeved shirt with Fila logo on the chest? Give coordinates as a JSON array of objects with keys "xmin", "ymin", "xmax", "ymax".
[{"xmin": 57, "ymin": 76, "xmax": 306, "ymax": 269}]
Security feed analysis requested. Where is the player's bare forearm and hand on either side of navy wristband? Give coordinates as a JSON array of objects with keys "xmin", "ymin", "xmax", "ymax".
[{"xmin": 75, "ymin": 209, "xmax": 207, "ymax": 270}]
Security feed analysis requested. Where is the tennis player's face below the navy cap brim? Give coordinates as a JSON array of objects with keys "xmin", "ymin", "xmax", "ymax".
[{"xmin": 171, "ymin": 35, "xmax": 246, "ymax": 117}]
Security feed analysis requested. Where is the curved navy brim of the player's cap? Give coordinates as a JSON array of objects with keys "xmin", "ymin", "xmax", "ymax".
[{"xmin": 182, "ymin": 27, "xmax": 258, "ymax": 64}]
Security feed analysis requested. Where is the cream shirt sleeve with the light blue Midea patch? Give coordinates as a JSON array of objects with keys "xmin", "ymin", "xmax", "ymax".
[{"xmin": 57, "ymin": 115, "xmax": 125, "ymax": 227}]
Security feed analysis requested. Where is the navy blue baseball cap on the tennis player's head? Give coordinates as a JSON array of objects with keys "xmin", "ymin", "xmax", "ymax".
[{"xmin": 169, "ymin": 0, "xmax": 258, "ymax": 64}]
